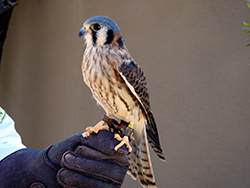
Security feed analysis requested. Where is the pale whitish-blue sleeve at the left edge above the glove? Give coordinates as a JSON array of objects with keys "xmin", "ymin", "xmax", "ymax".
[{"xmin": 0, "ymin": 107, "xmax": 26, "ymax": 161}]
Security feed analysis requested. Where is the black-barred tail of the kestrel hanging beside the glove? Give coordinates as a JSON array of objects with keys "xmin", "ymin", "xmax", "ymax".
[{"xmin": 127, "ymin": 128, "xmax": 157, "ymax": 188}]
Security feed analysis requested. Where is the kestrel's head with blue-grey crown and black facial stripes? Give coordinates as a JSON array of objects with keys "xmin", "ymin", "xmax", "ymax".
[{"xmin": 79, "ymin": 16, "xmax": 124, "ymax": 48}]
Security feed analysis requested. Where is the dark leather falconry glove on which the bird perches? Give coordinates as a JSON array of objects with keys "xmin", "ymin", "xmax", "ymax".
[{"xmin": 0, "ymin": 130, "xmax": 128, "ymax": 188}]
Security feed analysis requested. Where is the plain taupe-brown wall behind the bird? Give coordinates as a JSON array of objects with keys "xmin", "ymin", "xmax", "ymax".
[{"xmin": 0, "ymin": 0, "xmax": 250, "ymax": 188}]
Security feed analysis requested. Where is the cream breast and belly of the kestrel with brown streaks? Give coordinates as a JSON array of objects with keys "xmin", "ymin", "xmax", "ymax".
[{"xmin": 82, "ymin": 48, "xmax": 142, "ymax": 122}]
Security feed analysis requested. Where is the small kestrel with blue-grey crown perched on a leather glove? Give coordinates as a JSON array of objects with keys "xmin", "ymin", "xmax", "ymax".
[{"xmin": 79, "ymin": 16, "xmax": 165, "ymax": 187}]
